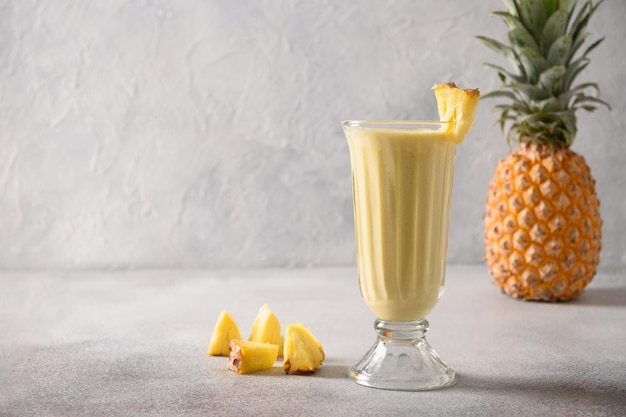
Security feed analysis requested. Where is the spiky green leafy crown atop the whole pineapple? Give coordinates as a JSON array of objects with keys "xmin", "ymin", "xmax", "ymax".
[{"xmin": 477, "ymin": 0, "xmax": 611, "ymax": 148}]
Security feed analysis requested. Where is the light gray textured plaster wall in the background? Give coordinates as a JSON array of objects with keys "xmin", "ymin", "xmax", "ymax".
[{"xmin": 0, "ymin": 0, "xmax": 626, "ymax": 269}]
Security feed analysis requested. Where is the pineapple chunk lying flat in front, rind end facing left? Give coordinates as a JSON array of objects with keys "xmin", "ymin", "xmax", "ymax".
[{"xmin": 228, "ymin": 340, "xmax": 278, "ymax": 374}]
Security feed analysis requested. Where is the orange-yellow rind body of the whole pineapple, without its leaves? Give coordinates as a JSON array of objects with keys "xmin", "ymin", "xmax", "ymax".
[{"xmin": 484, "ymin": 146, "xmax": 602, "ymax": 301}]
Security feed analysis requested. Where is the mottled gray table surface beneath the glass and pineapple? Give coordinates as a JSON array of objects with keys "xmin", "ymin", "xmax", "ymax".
[{"xmin": 0, "ymin": 266, "xmax": 626, "ymax": 416}]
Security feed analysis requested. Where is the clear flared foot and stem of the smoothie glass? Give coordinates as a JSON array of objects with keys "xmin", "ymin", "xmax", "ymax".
[{"xmin": 348, "ymin": 319, "xmax": 456, "ymax": 391}]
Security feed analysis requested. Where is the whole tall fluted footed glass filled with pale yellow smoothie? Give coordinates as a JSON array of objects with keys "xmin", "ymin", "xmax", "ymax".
[{"xmin": 342, "ymin": 121, "xmax": 456, "ymax": 391}]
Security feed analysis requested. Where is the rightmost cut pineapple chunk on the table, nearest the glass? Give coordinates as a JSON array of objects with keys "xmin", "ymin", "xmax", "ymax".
[{"xmin": 283, "ymin": 322, "xmax": 325, "ymax": 374}]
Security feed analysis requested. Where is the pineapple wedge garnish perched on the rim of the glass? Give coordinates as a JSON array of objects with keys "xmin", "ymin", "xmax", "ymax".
[{"xmin": 433, "ymin": 82, "xmax": 480, "ymax": 144}]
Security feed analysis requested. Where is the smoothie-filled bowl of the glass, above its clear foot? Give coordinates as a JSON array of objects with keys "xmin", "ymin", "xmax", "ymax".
[{"xmin": 344, "ymin": 122, "xmax": 456, "ymax": 321}]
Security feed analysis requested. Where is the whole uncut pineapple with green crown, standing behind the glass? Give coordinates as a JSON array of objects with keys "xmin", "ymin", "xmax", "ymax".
[{"xmin": 478, "ymin": 0, "xmax": 609, "ymax": 301}]
